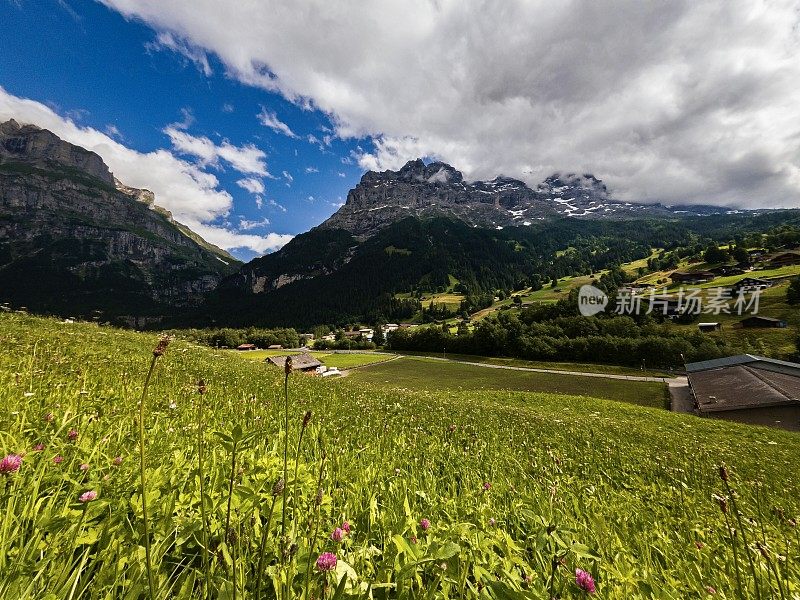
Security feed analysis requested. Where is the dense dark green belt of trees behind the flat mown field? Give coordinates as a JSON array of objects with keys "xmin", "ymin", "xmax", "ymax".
[{"xmin": 387, "ymin": 292, "xmax": 729, "ymax": 367}]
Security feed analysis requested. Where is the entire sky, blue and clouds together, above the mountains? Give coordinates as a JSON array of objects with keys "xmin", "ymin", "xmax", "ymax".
[{"xmin": 0, "ymin": 0, "xmax": 800, "ymax": 258}]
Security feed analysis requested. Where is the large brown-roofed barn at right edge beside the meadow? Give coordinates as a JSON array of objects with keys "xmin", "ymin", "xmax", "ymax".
[{"xmin": 686, "ymin": 354, "xmax": 800, "ymax": 431}]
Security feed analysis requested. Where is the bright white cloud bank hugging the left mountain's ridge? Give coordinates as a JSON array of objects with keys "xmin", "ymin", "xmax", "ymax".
[{"xmin": 0, "ymin": 87, "xmax": 291, "ymax": 252}]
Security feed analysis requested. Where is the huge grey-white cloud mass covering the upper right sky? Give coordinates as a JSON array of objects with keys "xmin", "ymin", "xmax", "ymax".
[{"xmin": 102, "ymin": 0, "xmax": 800, "ymax": 206}]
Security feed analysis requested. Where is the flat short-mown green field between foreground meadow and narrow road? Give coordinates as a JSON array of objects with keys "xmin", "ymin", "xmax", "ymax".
[{"xmin": 351, "ymin": 356, "xmax": 667, "ymax": 408}]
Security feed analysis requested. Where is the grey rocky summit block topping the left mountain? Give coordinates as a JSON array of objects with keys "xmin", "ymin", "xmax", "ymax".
[{"xmin": 0, "ymin": 119, "xmax": 114, "ymax": 186}]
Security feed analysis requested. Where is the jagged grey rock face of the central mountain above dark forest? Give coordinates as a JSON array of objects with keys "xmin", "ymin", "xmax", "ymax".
[{"xmin": 322, "ymin": 159, "xmax": 558, "ymax": 237}]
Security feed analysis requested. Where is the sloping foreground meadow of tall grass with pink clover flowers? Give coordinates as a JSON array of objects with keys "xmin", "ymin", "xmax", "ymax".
[{"xmin": 0, "ymin": 314, "xmax": 800, "ymax": 600}]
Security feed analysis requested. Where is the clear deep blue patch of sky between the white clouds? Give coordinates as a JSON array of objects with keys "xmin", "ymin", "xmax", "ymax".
[{"xmin": 0, "ymin": 0, "xmax": 365, "ymax": 259}]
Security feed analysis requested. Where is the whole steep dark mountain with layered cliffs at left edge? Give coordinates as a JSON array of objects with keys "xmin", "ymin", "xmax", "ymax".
[{"xmin": 0, "ymin": 121, "xmax": 238, "ymax": 323}]
